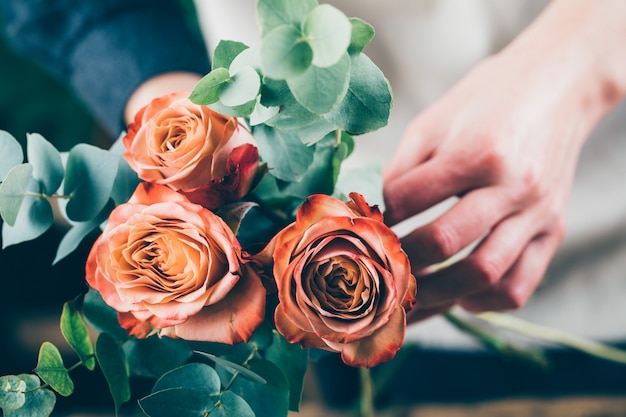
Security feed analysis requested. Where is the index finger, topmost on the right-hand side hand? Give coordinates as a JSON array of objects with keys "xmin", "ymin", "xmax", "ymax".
[{"xmin": 383, "ymin": 158, "xmax": 470, "ymax": 226}]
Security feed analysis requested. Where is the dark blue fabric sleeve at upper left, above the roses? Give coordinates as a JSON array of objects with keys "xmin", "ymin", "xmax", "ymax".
[{"xmin": 0, "ymin": 0, "xmax": 209, "ymax": 135}]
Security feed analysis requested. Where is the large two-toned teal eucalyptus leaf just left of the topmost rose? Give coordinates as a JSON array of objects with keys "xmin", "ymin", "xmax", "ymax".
[{"xmin": 63, "ymin": 143, "xmax": 119, "ymax": 222}]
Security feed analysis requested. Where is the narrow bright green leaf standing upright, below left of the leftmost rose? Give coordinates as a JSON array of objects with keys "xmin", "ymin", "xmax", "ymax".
[{"xmin": 61, "ymin": 300, "xmax": 96, "ymax": 371}]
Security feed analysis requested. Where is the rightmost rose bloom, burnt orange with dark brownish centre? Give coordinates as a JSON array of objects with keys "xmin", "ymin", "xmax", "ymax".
[{"xmin": 259, "ymin": 193, "xmax": 417, "ymax": 367}]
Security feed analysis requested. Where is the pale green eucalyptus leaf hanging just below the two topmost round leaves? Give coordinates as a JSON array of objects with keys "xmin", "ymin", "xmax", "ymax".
[{"xmin": 287, "ymin": 51, "xmax": 350, "ymax": 114}]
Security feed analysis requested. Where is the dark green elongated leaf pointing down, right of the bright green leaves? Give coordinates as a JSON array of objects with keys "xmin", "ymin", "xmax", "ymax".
[{"xmin": 96, "ymin": 333, "xmax": 130, "ymax": 414}]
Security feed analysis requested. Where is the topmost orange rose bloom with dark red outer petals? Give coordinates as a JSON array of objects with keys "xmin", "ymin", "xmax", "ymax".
[{"xmin": 123, "ymin": 92, "xmax": 259, "ymax": 209}]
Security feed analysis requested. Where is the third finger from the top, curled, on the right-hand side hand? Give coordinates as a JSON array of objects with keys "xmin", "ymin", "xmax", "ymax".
[{"xmin": 417, "ymin": 210, "xmax": 536, "ymax": 308}]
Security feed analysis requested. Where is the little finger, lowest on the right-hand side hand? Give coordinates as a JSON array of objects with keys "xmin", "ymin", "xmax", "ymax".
[{"xmin": 459, "ymin": 231, "xmax": 560, "ymax": 312}]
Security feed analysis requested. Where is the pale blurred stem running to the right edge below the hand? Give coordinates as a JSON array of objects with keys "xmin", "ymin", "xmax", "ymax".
[{"xmin": 476, "ymin": 312, "xmax": 626, "ymax": 364}]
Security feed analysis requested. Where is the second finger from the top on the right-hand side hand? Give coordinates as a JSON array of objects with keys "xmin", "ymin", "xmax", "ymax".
[{"xmin": 402, "ymin": 187, "xmax": 517, "ymax": 269}]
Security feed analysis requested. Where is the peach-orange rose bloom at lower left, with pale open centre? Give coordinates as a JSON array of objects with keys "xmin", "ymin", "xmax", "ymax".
[{"xmin": 86, "ymin": 183, "xmax": 265, "ymax": 344}]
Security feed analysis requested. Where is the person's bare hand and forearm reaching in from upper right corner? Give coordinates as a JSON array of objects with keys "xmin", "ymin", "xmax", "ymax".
[{"xmin": 384, "ymin": 0, "xmax": 626, "ymax": 320}]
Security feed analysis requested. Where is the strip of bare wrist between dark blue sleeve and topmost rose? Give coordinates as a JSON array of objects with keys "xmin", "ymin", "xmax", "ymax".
[{"xmin": 124, "ymin": 72, "xmax": 202, "ymax": 124}]
